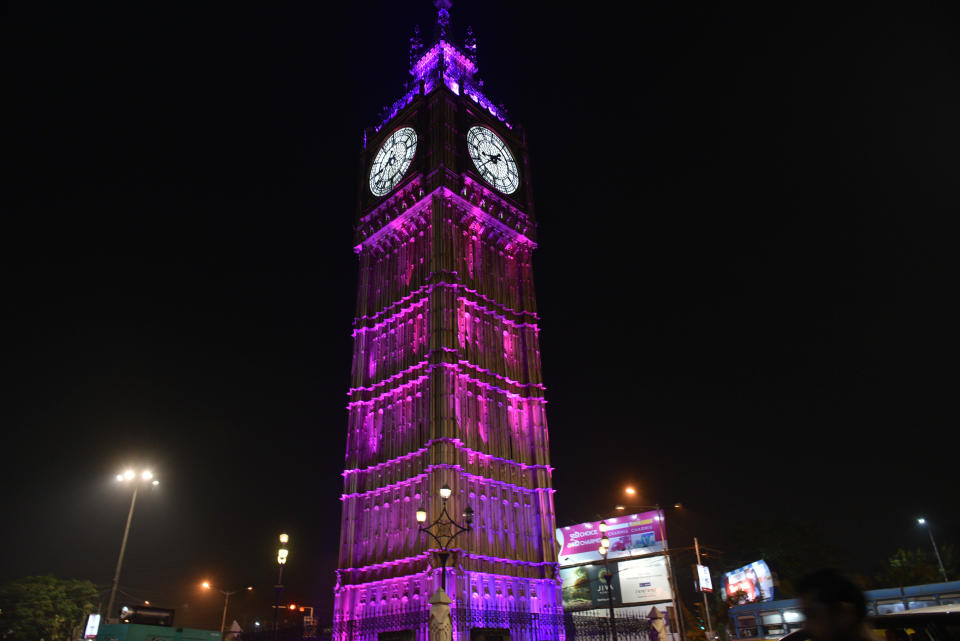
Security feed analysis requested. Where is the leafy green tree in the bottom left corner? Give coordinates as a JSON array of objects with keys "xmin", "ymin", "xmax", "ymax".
[{"xmin": 0, "ymin": 575, "xmax": 97, "ymax": 641}]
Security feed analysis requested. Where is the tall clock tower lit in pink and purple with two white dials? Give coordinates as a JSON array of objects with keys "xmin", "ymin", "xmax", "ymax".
[{"xmin": 334, "ymin": 2, "xmax": 564, "ymax": 641}]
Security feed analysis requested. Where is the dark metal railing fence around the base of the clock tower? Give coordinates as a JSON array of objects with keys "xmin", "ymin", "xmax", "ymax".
[{"xmin": 332, "ymin": 607, "xmax": 652, "ymax": 641}]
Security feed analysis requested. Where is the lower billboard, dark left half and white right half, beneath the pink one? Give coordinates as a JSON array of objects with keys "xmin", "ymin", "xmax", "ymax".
[{"xmin": 560, "ymin": 556, "xmax": 672, "ymax": 610}]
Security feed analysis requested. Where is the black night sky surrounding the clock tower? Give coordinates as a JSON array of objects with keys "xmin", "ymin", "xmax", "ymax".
[{"xmin": 0, "ymin": 0, "xmax": 960, "ymax": 627}]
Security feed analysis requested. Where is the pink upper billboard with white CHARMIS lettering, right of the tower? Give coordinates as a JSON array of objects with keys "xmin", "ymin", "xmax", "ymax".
[{"xmin": 557, "ymin": 511, "xmax": 663, "ymax": 567}]
